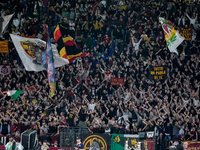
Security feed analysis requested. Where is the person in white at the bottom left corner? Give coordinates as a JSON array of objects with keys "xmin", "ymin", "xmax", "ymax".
[{"xmin": 5, "ymin": 135, "xmax": 24, "ymax": 150}]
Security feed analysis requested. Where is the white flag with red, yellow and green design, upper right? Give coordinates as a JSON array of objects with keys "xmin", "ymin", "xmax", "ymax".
[{"xmin": 159, "ymin": 17, "xmax": 184, "ymax": 54}]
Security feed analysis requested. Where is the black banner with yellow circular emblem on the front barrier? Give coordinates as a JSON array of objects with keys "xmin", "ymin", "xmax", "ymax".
[{"xmin": 80, "ymin": 134, "xmax": 110, "ymax": 150}]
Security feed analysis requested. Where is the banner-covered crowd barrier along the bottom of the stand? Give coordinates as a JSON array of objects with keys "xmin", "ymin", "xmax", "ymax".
[{"xmin": 60, "ymin": 127, "xmax": 156, "ymax": 150}]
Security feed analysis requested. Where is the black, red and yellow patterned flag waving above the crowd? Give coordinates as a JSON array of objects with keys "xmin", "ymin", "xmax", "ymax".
[{"xmin": 54, "ymin": 25, "xmax": 88, "ymax": 63}]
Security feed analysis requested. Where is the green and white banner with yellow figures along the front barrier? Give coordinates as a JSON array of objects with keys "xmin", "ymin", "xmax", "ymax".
[{"xmin": 111, "ymin": 134, "xmax": 141, "ymax": 150}]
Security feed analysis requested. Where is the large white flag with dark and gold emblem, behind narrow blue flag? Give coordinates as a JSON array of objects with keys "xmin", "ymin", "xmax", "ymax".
[{"xmin": 10, "ymin": 34, "xmax": 69, "ymax": 71}]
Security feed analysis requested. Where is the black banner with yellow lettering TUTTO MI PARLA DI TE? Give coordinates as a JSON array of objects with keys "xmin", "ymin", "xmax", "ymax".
[{"xmin": 149, "ymin": 66, "xmax": 167, "ymax": 80}]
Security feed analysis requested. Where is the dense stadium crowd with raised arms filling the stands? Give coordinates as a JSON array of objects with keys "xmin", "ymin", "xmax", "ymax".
[{"xmin": 0, "ymin": 0, "xmax": 200, "ymax": 150}]
